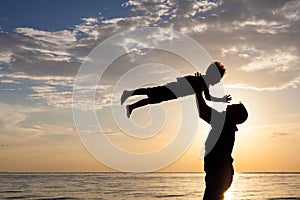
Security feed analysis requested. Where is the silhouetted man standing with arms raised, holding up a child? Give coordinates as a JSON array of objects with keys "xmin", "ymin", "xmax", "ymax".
[{"xmin": 196, "ymin": 75, "xmax": 248, "ymax": 200}]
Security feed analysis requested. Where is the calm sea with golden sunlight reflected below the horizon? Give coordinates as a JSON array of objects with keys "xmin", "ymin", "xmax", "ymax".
[{"xmin": 0, "ymin": 172, "xmax": 300, "ymax": 200}]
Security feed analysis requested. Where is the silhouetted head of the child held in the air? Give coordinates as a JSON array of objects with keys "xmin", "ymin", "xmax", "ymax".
[{"xmin": 206, "ymin": 61, "xmax": 226, "ymax": 85}]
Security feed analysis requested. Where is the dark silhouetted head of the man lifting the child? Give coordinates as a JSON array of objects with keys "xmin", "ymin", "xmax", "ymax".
[{"xmin": 226, "ymin": 103, "xmax": 248, "ymax": 124}]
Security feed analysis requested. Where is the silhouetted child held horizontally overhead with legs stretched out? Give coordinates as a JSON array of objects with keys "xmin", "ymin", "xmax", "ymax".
[{"xmin": 121, "ymin": 62, "xmax": 231, "ymax": 118}]
